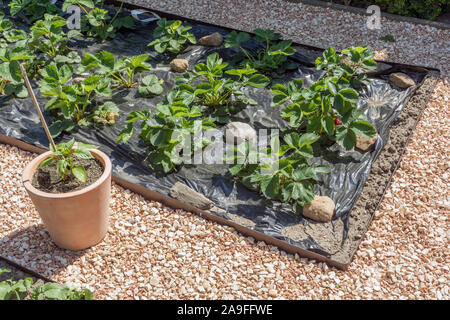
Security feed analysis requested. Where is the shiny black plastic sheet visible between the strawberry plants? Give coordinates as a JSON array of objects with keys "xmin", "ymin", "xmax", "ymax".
[{"xmin": 0, "ymin": 4, "xmax": 426, "ymax": 255}]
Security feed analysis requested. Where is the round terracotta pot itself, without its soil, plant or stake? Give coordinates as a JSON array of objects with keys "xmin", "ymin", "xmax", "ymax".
[{"xmin": 22, "ymin": 149, "xmax": 112, "ymax": 250}]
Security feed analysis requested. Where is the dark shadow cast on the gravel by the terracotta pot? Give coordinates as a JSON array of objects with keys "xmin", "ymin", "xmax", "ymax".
[{"xmin": 0, "ymin": 224, "xmax": 89, "ymax": 278}]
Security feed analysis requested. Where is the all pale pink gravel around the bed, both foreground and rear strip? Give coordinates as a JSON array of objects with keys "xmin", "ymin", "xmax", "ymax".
[{"xmin": 0, "ymin": 0, "xmax": 450, "ymax": 299}]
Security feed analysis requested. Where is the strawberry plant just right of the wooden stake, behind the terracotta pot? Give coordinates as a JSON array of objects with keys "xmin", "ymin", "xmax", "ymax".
[{"xmin": 40, "ymin": 64, "xmax": 111, "ymax": 137}]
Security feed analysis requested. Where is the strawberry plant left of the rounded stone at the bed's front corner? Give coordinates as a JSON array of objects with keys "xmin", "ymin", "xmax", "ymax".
[{"xmin": 229, "ymin": 132, "xmax": 330, "ymax": 213}]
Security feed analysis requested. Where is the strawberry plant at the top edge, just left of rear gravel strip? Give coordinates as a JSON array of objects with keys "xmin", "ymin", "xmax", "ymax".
[{"xmin": 62, "ymin": 0, "xmax": 134, "ymax": 40}]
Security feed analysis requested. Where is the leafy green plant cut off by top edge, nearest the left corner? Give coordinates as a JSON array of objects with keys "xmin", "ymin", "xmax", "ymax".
[{"xmin": 9, "ymin": 0, "xmax": 58, "ymax": 22}]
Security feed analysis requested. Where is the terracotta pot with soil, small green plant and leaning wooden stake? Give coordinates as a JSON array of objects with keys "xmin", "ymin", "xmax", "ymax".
[{"xmin": 21, "ymin": 65, "xmax": 112, "ymax": 250}]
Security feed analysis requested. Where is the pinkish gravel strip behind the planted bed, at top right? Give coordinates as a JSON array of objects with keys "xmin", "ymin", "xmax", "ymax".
[{"xmin": 126, "ymin": 0, "xmax": 450, "ymax": 77}]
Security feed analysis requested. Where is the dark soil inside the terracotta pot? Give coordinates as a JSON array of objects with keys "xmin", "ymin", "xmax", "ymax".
[{"xmin": 31, "ymin": 159, "xmax": 104, "ymax": 193}]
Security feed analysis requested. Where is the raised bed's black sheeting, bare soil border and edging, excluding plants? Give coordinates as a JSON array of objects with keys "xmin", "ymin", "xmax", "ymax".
[{"xmin": 0, "ymin": 0, "xmax": 438, "ymax": 268}]
